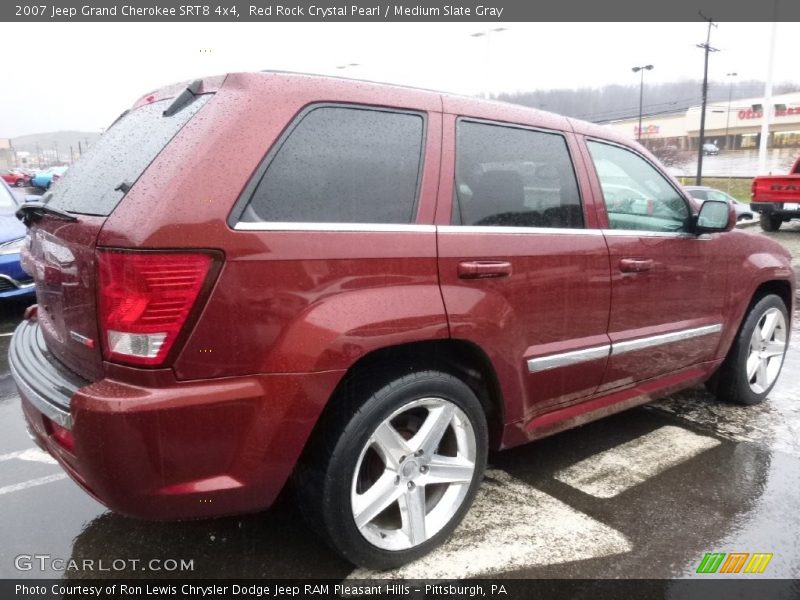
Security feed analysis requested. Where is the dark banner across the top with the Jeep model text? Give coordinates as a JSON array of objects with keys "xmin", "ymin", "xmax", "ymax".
[{"xmin": 0, "ymin": 0, "xmax": 800, "ymax": 22}]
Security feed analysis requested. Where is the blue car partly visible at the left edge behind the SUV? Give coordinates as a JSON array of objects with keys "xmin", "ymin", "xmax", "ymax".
[{"xmin": 0, "ymin": 181, "xmax": 35, "ymax": 300}]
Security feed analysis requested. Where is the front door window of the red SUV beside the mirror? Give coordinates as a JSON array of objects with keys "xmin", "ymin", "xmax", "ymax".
[{"xmin": 587, "ymin": 141, "xmax": 689, "ymax": 231}]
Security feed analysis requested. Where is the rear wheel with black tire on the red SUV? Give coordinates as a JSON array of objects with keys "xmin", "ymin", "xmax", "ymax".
[{"xmin": 296, "ymin": 371, "xmax": 488, "ymax": 570}]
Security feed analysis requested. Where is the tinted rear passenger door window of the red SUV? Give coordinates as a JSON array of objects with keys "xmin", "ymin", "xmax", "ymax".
[{"xmin": 452, "ymin": 121, "xmax": 583, "ymax": 228}]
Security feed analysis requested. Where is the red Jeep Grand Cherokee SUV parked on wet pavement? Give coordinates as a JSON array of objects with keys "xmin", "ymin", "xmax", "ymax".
[{"xmin": 10, "ymin": 73, "xmax": 795, "ymax": 568}]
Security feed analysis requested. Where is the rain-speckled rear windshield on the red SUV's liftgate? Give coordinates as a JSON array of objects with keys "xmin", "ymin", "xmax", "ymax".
[{"xmin": 48, "ymin": 94, "xmax": 212, "ymax": 217}]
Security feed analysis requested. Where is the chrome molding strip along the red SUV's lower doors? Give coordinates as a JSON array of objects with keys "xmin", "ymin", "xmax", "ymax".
[{"xmin": 527, "ymin": 323, "xmax": 722, "ymax": 373}]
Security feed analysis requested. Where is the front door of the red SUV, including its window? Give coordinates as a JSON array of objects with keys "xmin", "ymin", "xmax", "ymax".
[{"xmin": 586, "ymin": 139, "xmax": 729, "ymax": 391}]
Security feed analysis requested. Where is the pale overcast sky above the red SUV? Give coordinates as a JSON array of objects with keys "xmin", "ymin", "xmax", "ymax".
[{"xmin": 0, "ymin": 22, "xmax": 800, "ymax": 137}]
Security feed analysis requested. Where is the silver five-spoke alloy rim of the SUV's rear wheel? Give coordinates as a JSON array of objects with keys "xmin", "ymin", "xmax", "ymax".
[{"xmin": 350, "ymin": 398, "xmax": 477, "ymax": 550}]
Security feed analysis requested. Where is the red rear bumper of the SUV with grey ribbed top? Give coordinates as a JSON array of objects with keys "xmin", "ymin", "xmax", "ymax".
[{"xmin": 9, "ymin": 322, "xmax": 342, "ymax": 519}]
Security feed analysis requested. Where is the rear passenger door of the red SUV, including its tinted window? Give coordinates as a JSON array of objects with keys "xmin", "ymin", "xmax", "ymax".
[{"xmin": 437, "ymin": 115, "xmax": 610, "ymax": 422}]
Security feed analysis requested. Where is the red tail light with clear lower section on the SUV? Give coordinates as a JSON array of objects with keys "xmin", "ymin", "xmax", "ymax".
[{"xmin": 97, "ymin": 250, "xmax": 213, "ymax": 366}]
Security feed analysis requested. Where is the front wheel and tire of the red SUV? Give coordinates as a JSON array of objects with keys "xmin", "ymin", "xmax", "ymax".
[{"xmin": 715, "ymin": 294, "xmax": 789, "ymax": 405}]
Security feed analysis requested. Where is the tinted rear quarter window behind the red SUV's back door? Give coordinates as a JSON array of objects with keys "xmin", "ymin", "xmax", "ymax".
[{"xmin": 242, "ymin": 106, "xmax": 424, "ymax": 223}]
